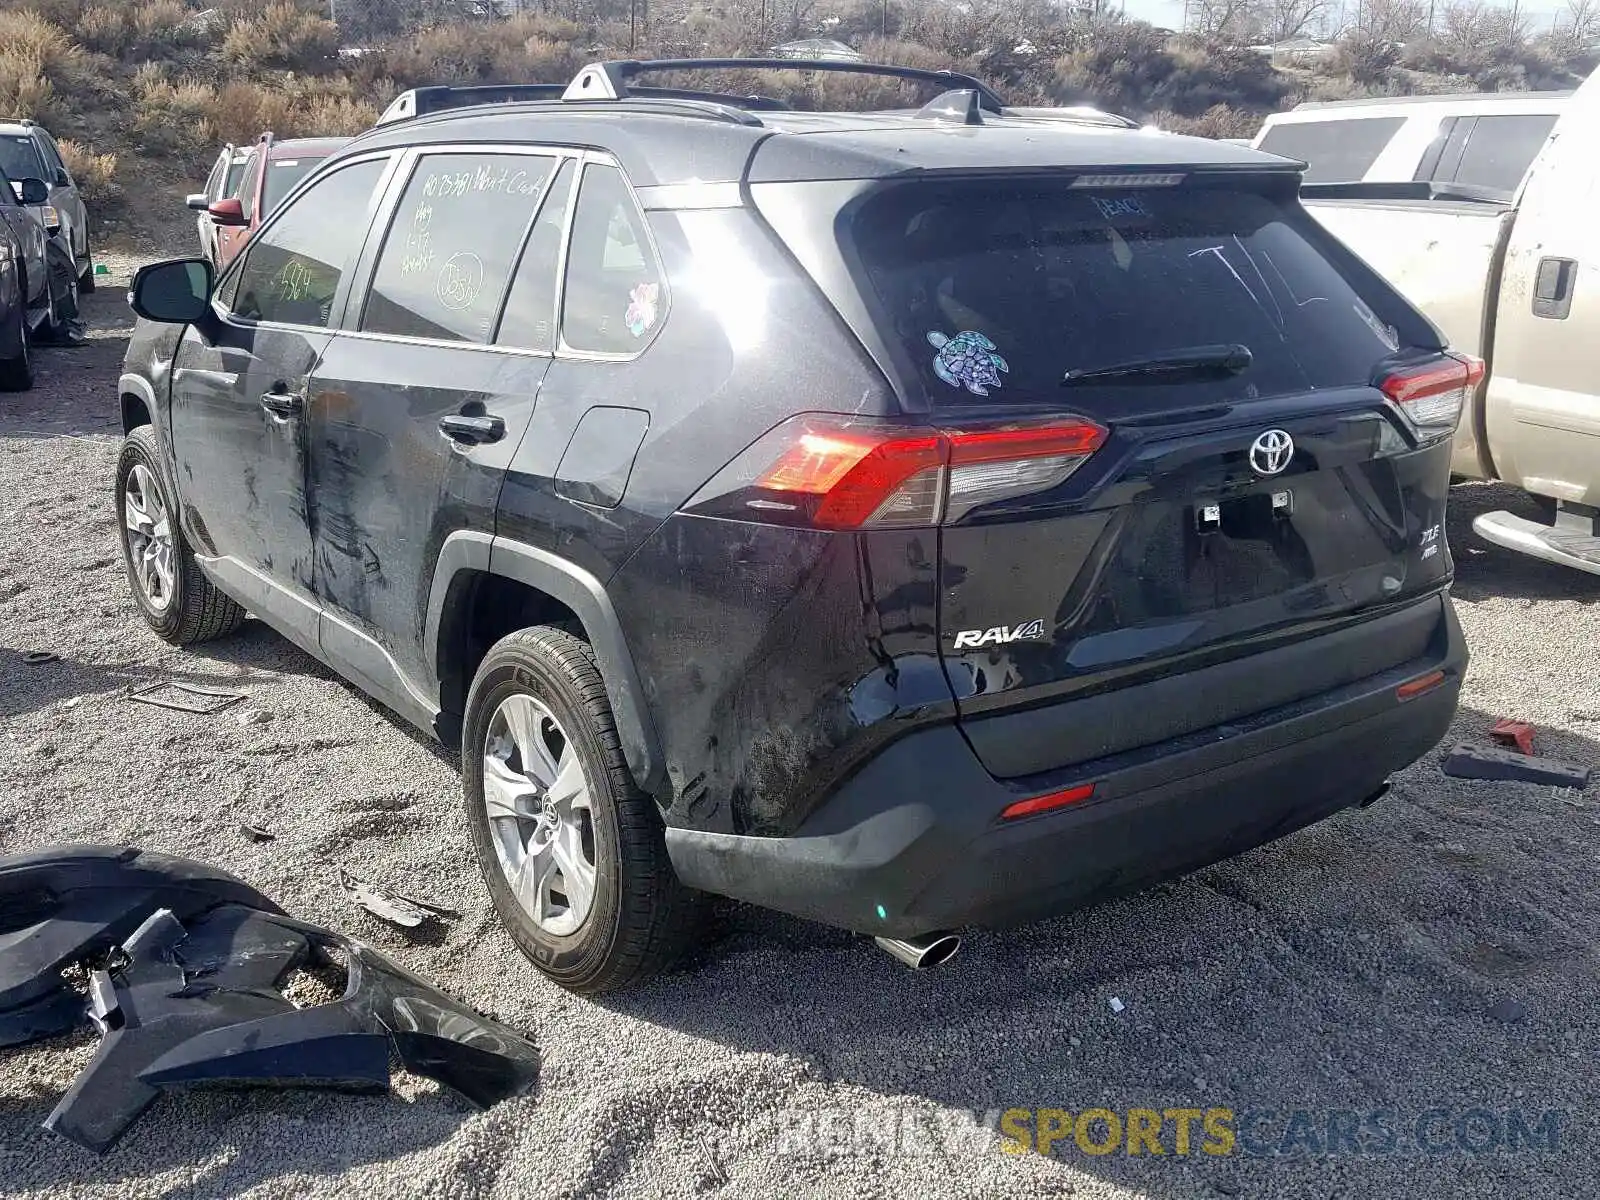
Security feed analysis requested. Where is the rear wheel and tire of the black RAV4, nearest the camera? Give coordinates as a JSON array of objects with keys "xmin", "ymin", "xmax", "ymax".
[{"xmin": 461, "ymin": 626, "xmax": 701, "ymax": 995}]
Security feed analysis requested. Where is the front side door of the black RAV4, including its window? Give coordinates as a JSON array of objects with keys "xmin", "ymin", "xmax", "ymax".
[{"xmin": 171, "ymin": 155, "xmax": 390, "ymax": 646}]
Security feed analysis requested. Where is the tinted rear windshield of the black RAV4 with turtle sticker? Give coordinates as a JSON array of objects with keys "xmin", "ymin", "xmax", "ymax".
[{"xmin": 853, "ymin": 182, "xmax": 1416, "ymax": 418}]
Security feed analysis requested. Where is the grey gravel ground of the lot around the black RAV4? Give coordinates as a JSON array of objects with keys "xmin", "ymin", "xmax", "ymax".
[{"xmin": 0, "ymin": 282, "xmax": 1600, "ymax": 1200}]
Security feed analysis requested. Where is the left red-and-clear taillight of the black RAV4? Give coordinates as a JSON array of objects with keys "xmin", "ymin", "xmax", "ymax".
[{"xmin": 685, "ymin": 416, "xmax": 1106, "ymax": 530}]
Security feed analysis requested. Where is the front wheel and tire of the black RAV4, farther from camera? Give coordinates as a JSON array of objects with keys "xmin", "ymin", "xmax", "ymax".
[{"xmin": 117, "ymin": 426, "xmax": 245, "ymax": 646}]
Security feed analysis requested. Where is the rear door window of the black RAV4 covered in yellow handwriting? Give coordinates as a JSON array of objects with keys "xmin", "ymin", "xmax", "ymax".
[{"xmin": 362, "ymin": 154, "xmax": 555, "ymax": 342}]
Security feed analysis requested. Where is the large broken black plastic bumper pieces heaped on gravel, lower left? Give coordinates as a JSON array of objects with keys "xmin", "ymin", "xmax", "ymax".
[{"xmin": 0, "ymin": 846, "xmax": 539, "ymax": 1152}]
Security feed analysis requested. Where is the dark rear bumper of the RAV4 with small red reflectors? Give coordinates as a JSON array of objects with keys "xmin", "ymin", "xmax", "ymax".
[{"xmin": 667, "ymin": 597, "xmax": 1467, "ymax": 938}]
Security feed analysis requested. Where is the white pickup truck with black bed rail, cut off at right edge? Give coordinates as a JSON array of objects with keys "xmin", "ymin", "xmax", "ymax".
[{"xmin": 1302, "ymin": 72, "xmax": 1600, "ymax": 574}]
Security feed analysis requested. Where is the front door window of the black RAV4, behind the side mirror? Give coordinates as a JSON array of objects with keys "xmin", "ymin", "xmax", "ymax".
[{"xmin": 232, "ymin": 158, "xmax": 387, "ymax": 326}]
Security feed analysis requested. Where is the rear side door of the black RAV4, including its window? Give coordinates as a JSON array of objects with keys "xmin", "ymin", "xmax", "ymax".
[{"xmin": 309, "ymin": 149, "xmax": 574, "ymax": 720}]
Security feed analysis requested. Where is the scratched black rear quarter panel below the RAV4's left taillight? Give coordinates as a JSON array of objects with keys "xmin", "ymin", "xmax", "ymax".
[{"xmin": 611, "ymin": 515, "xmax": 954, "ymax": 835}]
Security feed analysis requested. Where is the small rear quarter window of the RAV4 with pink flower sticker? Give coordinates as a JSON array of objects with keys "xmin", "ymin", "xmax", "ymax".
[{"xmin": 562, "ymin": 163, "xmax": 667, "ymax": 354}]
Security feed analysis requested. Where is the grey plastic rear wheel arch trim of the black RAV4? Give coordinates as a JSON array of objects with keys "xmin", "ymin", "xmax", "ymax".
[{"xmin": 424, "ymin": 530, "xmax": 667, "ymax": 802}]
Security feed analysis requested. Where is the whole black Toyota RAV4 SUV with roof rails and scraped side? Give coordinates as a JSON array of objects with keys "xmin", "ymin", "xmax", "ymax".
[{"xmin": 117, "ymin": 62, "xmax": 1482, "ymax": 992}]
